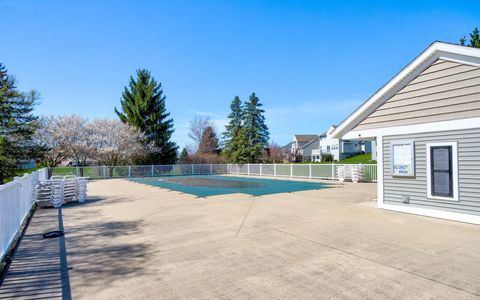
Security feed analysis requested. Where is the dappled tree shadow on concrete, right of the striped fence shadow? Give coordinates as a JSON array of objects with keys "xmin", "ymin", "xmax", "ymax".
[{"xmin": 61, "ymin": 199, "xmax": 151, "ymax": 287}]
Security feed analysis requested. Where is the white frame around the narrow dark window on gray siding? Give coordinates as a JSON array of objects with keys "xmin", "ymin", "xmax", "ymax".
[{"xmin": 425, "ymin": 142, "xmax": 458, "ymax": 201}]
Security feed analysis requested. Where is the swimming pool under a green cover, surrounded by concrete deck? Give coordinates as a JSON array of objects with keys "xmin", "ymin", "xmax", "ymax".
[{"xmin": 128, "ymin": 175, "xmax": 330, "ymax": 197}]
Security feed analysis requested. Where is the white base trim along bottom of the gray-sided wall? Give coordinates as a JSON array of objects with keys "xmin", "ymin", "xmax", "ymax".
[{"xmin": 378, "ymin": 204, "xmax": 480, "ymax": 225}]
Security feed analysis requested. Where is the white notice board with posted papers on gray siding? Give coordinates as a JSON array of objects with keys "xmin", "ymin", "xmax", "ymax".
[{"xmin": 390, "ymin": 141, "xmax": 415, "ymax": 177}]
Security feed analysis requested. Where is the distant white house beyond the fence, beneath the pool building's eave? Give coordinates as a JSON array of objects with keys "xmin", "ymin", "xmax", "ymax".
[{"xmin": 320, "ymin": 126, "xmax": 375, "ymax": 161}]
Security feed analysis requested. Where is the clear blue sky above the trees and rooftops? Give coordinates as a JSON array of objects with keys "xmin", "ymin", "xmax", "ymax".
[{"xmin": 0, "ymin": 0, "xmax": 480, "ymax": 146}]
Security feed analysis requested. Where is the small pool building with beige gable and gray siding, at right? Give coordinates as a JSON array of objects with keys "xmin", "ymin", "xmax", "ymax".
[{"xmin": 333, "ymin": 42, "xmax": 480, "ymax": 224}]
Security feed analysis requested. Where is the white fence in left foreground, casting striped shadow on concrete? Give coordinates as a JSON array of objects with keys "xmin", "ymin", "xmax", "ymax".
[{"xmin": 0, "ymin": 168, "xmax": 48, "ymax": 260}]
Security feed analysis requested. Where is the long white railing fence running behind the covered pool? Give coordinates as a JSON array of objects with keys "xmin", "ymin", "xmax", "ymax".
[{"xmin": 52, "ymin": 164, "xmax": 377, "ymax": 181}]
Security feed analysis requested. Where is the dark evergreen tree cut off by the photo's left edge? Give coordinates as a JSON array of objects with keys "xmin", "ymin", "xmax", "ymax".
[{"xmin": 0, "ymin": 64, "xmax": 39, "ymax": 183}]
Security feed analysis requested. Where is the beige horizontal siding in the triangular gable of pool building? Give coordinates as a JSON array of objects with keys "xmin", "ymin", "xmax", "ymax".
[{"xmin": 353, "ymin": 60, "xmax": 480, "ymax": 130}]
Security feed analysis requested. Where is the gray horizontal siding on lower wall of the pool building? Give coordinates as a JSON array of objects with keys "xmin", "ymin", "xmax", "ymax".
[{"xmin": 383, "ymin": 128, "xmax": 480, "ymax": 215}]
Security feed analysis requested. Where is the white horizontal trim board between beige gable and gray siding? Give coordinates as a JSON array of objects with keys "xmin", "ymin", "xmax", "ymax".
[{"xmin": 343, "ymin": 117, "xmax": 480, "ymax": 139}]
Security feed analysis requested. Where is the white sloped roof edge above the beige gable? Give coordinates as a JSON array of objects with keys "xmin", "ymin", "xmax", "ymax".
[{"xmin": 332, "ymin": 42, "xmax": 480, "ymax": 138}]
